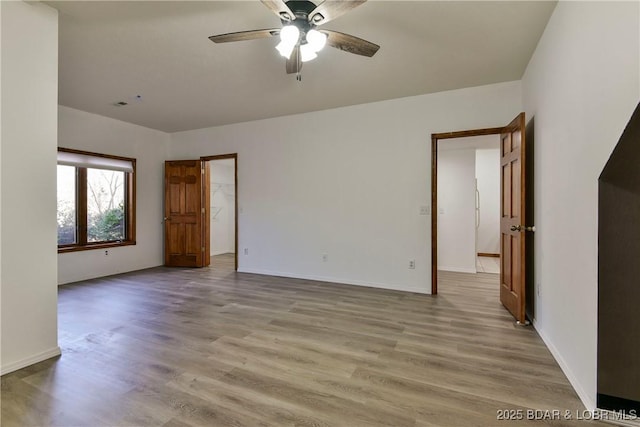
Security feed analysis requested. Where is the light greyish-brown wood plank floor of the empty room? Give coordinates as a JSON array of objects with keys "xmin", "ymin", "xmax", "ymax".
[{"xmin": 1, "ymin": 256, "xmax": 604, "ymax": 427}]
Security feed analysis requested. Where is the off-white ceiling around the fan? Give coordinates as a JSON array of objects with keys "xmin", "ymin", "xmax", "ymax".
[{"xmin": 45, "ymin": 0, "xmax": 556, "ymax": 132}]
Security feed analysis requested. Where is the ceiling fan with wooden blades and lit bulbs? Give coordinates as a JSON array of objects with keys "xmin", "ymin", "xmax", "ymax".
[{"xmin": 209, "ymin": 0, "xmax": 380, "ymax": 80}]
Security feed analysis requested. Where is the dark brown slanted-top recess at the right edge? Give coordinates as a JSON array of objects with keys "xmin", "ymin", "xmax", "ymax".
[{"xmin": 598, "ymin": 101, "xmax": 640, "ymax": 413}]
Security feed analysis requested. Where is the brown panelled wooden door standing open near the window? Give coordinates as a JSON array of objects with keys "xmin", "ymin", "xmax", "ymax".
[{"xmin": 164, "ymin": 160, "xmax": 209, "ymax": 267}]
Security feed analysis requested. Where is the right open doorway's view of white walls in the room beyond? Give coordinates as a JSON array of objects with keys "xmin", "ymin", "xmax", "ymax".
[{"xmin": 435, "ymin": 135, "xmax": 500, "ymax": 282}]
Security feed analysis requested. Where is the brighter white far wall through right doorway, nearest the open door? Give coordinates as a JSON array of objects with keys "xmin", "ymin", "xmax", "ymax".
[{"xmin": 476, "ymin": 148, "xmax": 500, "ymax": 254}]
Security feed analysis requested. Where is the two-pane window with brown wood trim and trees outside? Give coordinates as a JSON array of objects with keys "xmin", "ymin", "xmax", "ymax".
[{"xmin": 58, "ymin": 148, "xmax": 136, "ymax": 252}]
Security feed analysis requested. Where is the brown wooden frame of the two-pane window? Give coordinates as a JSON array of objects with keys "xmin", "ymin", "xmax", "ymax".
[{"xmin": 58, "ymin": 147, "xmax": 136, "ymax": 253}]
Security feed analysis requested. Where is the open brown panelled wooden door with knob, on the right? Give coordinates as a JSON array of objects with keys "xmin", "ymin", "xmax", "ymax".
[{"xmin": 500, "ymin": 113, "xmax": 527, "ymax": 324}]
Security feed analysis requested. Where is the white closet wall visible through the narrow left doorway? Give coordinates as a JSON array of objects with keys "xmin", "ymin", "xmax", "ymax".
[{"xmin": 209, "ymin": 159, "xmax": 236, "ymax": 256}]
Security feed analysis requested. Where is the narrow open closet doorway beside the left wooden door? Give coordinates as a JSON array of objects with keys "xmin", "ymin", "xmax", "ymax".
[{"xmin": 202, "ymin": 154, "xmax": 238, "ymax": 270}]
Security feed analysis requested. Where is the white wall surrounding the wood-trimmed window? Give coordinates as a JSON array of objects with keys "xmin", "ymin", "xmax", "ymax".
[{"xmin": 58, "ymin": 106, "xmax": 169, "ymax": 284}]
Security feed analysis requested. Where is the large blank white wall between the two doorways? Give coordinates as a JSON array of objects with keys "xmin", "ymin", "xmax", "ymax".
[{"xmin": 171, "ymin": 82, "xmax": 522, "ymax": 293}]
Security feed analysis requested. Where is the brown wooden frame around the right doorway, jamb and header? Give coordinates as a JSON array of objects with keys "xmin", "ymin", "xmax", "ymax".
[{"xmin": 431, "ymin": 126, "xmax": 504, "ymax": 295}]
